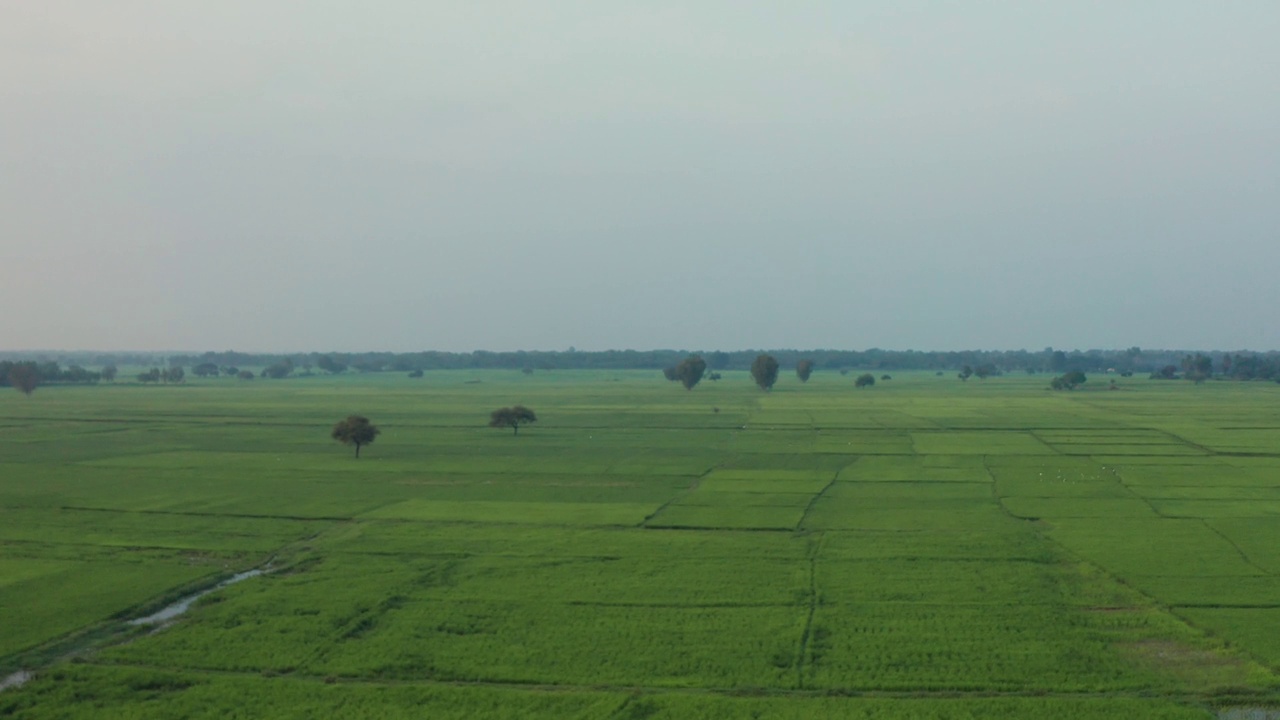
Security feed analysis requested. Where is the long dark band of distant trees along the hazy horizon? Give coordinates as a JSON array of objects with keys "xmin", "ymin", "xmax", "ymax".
[{"xmin": 0, "ymin": 347, "xmax": 1280, "ymax": 393}]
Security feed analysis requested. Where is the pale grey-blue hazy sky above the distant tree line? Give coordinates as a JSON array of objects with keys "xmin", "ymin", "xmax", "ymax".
[{"xmin": 0, "ymin": 0, "xmax": 1280, "ymax": 351}]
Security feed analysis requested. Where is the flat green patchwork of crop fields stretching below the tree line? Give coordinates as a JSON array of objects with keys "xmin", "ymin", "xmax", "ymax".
[{"xmin": 0, "ymin": 372, "xmax": 1280, "ymax": 720}]
